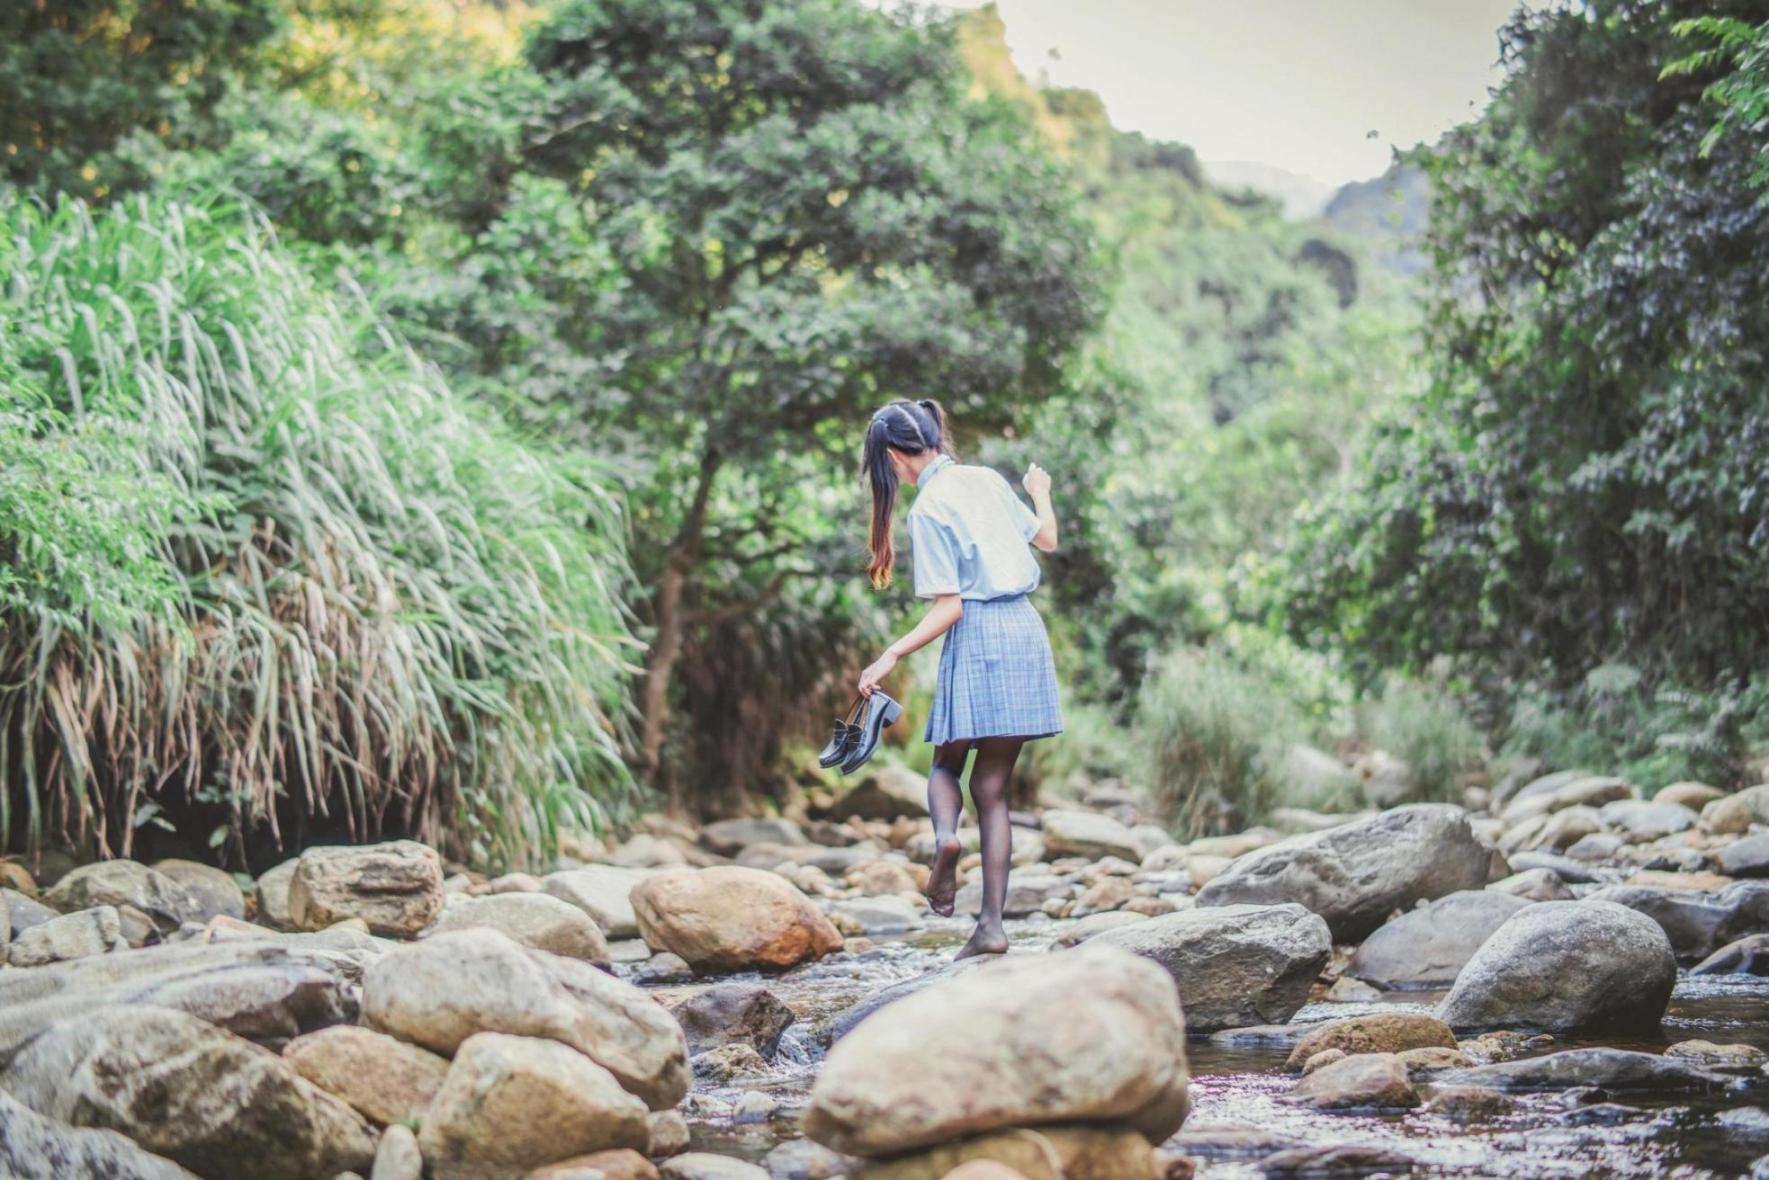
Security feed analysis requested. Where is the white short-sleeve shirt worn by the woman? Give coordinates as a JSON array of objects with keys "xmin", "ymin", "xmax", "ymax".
[{"xmin": 909, "ymin": 455, "xmax": 1038, "ymax": 600}]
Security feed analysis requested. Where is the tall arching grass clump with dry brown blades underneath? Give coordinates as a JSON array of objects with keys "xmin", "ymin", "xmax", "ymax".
[{"xmin": 0, "ymin": 196, "xmax": 633, "ymax": 863}]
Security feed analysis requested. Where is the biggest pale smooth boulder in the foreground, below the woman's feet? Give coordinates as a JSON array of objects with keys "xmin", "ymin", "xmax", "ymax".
[{"xmin": 805, "ymin": 943, "xmax": 1187, "ymax": 1155}]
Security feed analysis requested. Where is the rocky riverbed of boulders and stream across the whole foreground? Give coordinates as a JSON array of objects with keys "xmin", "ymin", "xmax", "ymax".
[{"xmin": 10, "ymin": 770, "xmax": 1769, "ymax": 1180}]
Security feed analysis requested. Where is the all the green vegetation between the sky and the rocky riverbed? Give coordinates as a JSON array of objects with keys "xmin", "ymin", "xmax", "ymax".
[{"xmin": 0, "ymin": 0, "xmax": 1769, "ymax": 860}]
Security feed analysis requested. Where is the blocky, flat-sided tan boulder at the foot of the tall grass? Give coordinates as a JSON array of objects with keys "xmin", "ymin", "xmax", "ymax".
[{"xmin": 288, "ymin": 840, "xmax": 442, "ymax": 938}]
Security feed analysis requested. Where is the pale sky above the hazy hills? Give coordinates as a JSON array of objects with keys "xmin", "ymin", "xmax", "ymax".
[{"xmin": 941, "ymin": 0, "xmax": 1516, "ymax": 184}]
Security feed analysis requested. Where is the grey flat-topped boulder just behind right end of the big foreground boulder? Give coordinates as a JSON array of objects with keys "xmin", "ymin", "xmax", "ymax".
[{"xmin": 1084, "ymin": 906, "xmax": 1332, "ymax": 1033}]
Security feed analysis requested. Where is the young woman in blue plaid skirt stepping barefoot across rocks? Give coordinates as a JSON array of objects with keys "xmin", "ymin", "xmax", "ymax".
[{"xmin": 860, "ymin": 400, "xmax": 1063, "ymax": 959}]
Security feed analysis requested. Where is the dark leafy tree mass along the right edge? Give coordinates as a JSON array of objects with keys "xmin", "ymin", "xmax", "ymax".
[{"xmin": 1290, "ymin": 0, "xmax": 1769, "ymax": 697}]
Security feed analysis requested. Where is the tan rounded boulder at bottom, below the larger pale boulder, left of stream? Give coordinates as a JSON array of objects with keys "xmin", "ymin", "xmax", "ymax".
[{"xmin": 417, "ymin": 1033, "xmax": 651, "ymax": 1180}]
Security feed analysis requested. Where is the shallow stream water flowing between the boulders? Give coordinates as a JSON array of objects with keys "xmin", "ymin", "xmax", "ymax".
[{"xmin": 640, "ymin": 915, "xmax": 1769, "ymax": 1180}]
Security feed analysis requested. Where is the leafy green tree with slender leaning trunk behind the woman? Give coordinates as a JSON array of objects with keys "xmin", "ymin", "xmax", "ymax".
[{"xmin": 524, "ymin": 0, "xmax": 1093, "ymax": 792}]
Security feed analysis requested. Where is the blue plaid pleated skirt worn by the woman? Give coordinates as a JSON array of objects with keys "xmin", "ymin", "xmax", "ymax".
[{"xmin": 923, "ymin": 594, "xmax": 1063, "ymax": 745}]
